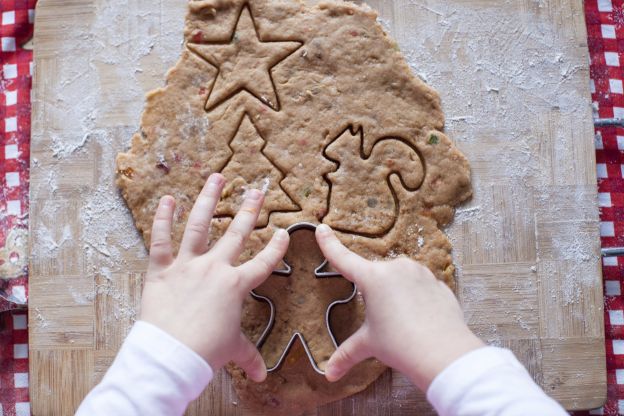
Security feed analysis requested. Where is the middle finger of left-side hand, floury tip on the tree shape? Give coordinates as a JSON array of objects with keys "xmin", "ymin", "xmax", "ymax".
[{"xmin": 212, "ymin": 189, "xmax": 264, "ymax": 264}]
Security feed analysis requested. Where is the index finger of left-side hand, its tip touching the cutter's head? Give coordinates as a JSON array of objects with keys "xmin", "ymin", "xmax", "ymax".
[{"xmin": 238, "ymin": 229, "xmax": 290, "ymax": 292}]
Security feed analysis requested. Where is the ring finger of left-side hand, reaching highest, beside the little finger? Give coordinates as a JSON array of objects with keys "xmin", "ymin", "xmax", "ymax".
[{"xmin": 180, "ymin": 173, "xmax": 225, "ymax": 257}]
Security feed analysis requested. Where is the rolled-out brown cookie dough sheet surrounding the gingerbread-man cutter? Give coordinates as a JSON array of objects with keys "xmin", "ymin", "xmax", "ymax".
[{"xmin": 117, "ymin": 0, "xmax": 472, "ymax": 415}]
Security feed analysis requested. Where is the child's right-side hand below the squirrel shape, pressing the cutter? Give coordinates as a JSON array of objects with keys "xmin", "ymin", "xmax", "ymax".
[{"xmin": 316, "ymin": 225, "xmax": 484, "ymax": 391}]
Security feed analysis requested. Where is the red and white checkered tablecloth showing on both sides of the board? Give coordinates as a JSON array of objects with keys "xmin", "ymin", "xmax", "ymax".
[{"xmin": 0, "ymin": 0, "xmax": 624, "ymax": 416}]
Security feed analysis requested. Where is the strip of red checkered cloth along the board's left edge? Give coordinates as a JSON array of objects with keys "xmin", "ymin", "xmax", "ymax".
[{"xmin": 0, "ymin": 0, "xmax": 36, "ymax": 416}]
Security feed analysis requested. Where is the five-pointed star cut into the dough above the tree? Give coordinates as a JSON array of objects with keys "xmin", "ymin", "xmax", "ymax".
[{"xmin": 187, "ymin": 6, "xmax": 302, "ymax": 111}]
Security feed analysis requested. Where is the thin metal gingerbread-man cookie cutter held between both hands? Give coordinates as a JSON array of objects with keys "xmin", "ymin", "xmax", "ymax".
[{"xmin": 251, "ymin": 222, "xmax": 357, "ymax": 375}]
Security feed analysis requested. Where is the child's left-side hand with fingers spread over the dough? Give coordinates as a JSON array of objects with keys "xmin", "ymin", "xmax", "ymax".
[{"xmin": 140, "ymin": 174, "xmax": 289, "ymax": 381}]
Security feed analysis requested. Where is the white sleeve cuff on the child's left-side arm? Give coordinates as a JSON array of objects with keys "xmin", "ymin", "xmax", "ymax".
[{"xmin": 76, "ymin": 321, "xmax": 213, "ymax": 416}]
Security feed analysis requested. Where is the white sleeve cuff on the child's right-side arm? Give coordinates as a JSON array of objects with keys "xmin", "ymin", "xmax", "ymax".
[{"xmin": 427, "ymin": 347, "xmax": 568, "ymax": 416}]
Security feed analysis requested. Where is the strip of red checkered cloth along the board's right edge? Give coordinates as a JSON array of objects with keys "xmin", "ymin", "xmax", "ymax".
[{"xmin": 585, "ymin": 0, "xmax": 624, "ymax": 415}]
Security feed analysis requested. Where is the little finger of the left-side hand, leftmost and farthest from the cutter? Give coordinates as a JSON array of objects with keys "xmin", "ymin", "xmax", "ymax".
[{"xmin": 149, "ymin": 195, "xmax": 175, "ymax": 268}]
